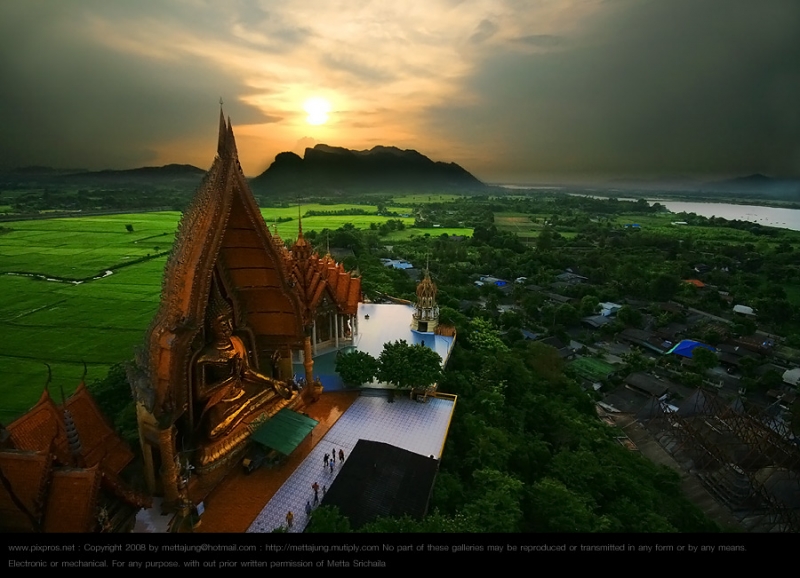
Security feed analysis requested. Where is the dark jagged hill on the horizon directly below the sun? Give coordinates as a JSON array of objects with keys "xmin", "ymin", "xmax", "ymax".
[{"xmin": 251, "ymin": 144, "xmax": 485, "ymax": 193}]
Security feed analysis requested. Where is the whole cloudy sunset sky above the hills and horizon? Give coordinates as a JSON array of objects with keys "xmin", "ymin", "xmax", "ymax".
[{"xmin": 0, "ymin": 0, "xmax": 800, "ymax": 182}]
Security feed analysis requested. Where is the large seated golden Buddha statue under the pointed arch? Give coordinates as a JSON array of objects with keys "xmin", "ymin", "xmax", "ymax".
[{"xmin": 194, "ymin": 284, "xmax": 293, "ymax": 440}]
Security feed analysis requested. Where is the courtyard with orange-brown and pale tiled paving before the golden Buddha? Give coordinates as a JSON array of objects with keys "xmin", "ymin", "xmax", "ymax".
[{"xmin": 134, "ymin": 391, "xmax": 455, "ymax": 532}]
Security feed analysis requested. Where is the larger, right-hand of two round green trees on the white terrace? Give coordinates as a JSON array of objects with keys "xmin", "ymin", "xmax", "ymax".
[{"xmin": 378, "ymin": 339, "xmax": 442, "ymax": 388}]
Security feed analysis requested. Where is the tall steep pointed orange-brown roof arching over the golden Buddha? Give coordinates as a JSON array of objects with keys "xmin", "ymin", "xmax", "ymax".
[{"xmin": 142, "ymin": 110, "xmax": 303, "ymax": 417}]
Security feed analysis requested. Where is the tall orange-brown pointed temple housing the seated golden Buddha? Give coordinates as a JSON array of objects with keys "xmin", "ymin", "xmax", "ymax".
[{"xmin": 128, "ymin": 110, "xmax": 361, "ymax": 511}]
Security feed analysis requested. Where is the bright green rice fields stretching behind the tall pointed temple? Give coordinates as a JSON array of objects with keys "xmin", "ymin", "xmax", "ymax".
[{"xmin": 0, "ymin": 205, "xmax": 456, "ymax": 424}]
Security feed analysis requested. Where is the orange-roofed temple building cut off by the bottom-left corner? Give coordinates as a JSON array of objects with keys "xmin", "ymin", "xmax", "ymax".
[{"xmin": 0, "ymin": 383, "xmax": 152, "ymax": 532}]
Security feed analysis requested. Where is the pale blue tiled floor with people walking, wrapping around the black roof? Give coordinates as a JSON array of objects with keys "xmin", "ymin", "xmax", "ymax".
[{"xmin": 247, "ymin": 397, "xmax": 454, "ymax": 532}]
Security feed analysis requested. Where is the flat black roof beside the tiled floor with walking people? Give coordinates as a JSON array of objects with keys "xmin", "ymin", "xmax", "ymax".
[{"xmin": 322, "ymin": 440, "xmax": 439, "ymax": 528}]
